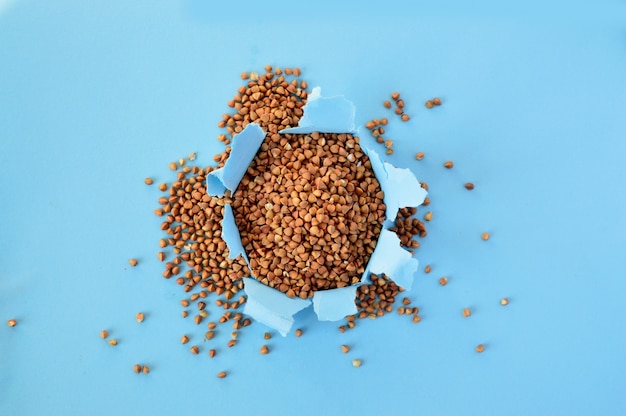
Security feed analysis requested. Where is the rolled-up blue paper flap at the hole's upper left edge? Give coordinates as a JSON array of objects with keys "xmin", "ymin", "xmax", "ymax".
[{"xmin": 206, "ymin": 123, "xmax": 265, "ymax": 196}]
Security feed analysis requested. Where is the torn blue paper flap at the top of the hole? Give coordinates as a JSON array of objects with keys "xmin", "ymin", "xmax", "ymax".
[{"xmin": 280, "ymin": 87, "xmax": 356, "ymax": 134}]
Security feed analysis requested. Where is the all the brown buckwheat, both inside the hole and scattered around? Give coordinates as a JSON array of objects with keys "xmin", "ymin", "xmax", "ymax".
[{"xmin": 111, "ymin": 66, "xmax": 508, "ymax": 378}]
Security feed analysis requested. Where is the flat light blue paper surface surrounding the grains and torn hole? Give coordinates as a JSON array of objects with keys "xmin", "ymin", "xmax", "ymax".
[{"xmin": 0, "ymin": 0, "xmax": 626, "ymax": 415}]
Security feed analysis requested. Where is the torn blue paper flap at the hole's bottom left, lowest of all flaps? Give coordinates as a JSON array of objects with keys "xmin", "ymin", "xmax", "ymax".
[{"xmin": 243, "ymin": 277, "xmax": 310, "ymax": 336}]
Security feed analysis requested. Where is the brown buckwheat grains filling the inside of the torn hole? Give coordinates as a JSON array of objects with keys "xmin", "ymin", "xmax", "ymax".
[{"xmin": 232, "ymin": 133, "xmax": 385, "ymax": 299}]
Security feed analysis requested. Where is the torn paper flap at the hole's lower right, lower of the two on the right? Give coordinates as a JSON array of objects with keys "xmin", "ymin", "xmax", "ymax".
[{"xmin": 364, "ymin": 229, "xmax": 419, "ymax": 290}]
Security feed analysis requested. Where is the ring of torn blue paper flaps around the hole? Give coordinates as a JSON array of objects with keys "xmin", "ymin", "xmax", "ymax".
[{"xmin": 207, "ymin": 91, "xmax": 427, "ymax": 336}]
